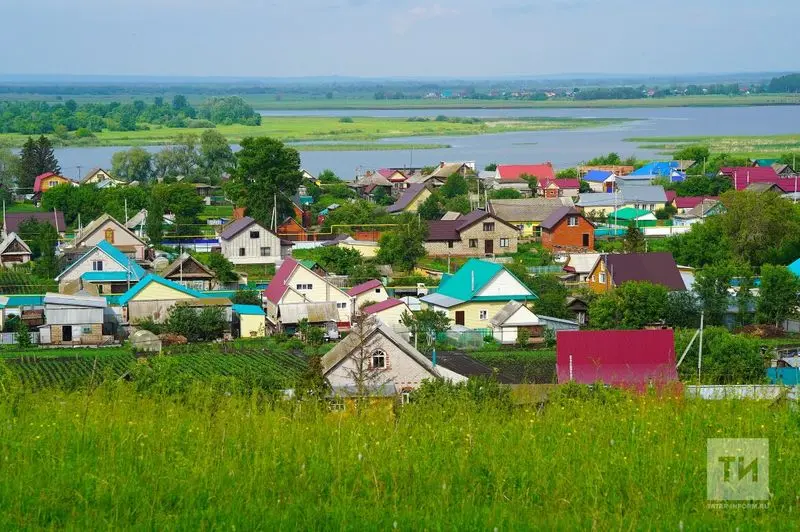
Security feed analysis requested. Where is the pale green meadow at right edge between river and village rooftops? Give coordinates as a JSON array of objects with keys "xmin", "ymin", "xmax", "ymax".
[{"xmin": 625, "ymin": 134, "xmax": 800, "ymax": 158}]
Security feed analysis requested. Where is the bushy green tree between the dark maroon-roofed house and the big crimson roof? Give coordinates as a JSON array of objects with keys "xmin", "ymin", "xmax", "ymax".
[{"xmin": 589, "ymin": 281, "xmax": 667, "ymax": 329}]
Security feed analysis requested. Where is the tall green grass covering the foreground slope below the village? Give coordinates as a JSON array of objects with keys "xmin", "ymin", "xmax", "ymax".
[{"xmin": 0, "ymin": 383, "xmax": 800, "ymax": 530}]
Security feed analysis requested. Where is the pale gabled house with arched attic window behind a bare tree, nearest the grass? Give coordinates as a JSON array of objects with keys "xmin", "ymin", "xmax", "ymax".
[{"xmin": 322, "ymin": 318, "xmax": 441, "ymax": 397}]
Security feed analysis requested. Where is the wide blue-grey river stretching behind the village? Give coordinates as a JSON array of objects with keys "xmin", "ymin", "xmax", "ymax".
[{"xmin": 48, "ymin": 106, "xmax": 800, "ymax": 179}]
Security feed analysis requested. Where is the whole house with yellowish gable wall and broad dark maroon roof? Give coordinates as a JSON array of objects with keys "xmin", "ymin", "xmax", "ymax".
[{"xmin": 587, "ymin": 253, "xmax": 686, "ymax": 293}]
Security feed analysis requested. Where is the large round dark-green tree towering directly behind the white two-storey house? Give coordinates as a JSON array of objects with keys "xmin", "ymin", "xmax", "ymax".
[{"xmin": 233, "ymin": 137, "xmax": 303, "ymax": 223}]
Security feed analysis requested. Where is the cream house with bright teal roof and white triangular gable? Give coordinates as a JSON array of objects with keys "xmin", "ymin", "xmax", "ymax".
[{"xmin": 420, "ymin": 259, "xmax": 537, "ymax": 329}]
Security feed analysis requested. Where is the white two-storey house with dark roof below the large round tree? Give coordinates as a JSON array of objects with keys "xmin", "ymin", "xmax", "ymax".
[{"xmin": 219, "ymin": 216, "xmax": 292, "ymax": 264}]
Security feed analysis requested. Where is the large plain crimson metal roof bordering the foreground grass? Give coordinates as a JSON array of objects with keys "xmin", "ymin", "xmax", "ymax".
[{"xmin": 556, "ymin": 329, "xmax": 678, "ymax": 390}]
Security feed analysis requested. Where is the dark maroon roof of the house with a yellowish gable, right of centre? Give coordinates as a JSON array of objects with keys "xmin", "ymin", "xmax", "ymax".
[{"xmin": 604, "ymin": 252, "xmax": 686, "ymax": 290}]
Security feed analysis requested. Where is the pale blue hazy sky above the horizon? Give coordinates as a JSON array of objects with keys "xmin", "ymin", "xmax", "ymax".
[{"xmin": 0, "ymin": 0, "xmax": 800, "ymax": 78}]
